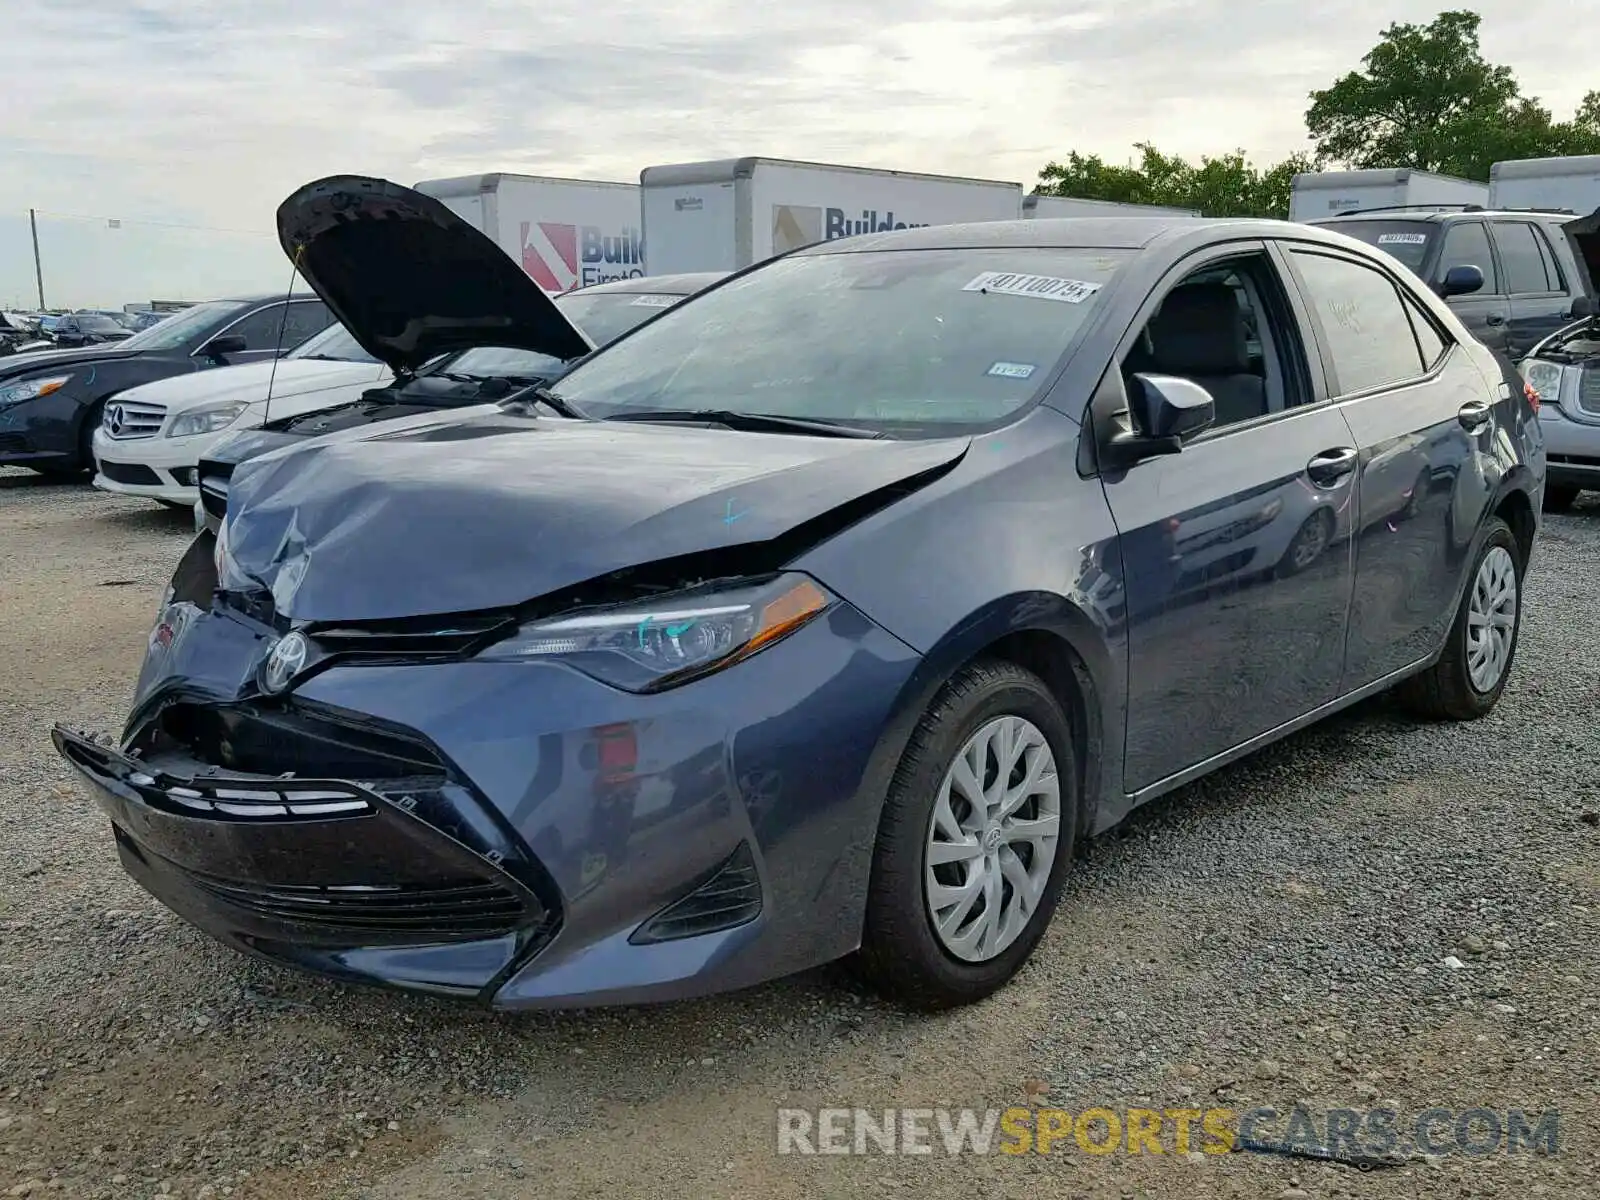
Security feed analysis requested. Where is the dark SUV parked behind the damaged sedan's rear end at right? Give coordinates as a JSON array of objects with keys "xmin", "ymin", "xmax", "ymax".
[{"xmin": 1310, "ymin": 205, "xmax": 1595, "ymax": 363}]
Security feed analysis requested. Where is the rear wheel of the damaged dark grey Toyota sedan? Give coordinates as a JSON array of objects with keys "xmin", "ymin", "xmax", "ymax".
[{"xmin": 1397, "ymin": 517, "xmax": 1523, "ymax": 722}]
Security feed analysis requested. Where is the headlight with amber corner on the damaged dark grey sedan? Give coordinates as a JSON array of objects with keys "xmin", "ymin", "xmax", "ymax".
[{"xmin": 478, "ymin": 573, "xmax": 835, "ymax": 691}]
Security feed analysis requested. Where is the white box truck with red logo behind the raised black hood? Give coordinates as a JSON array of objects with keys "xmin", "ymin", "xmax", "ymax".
[{"xmin": 416, "ymin": 173, "xmax": 645, "ymax": 293}]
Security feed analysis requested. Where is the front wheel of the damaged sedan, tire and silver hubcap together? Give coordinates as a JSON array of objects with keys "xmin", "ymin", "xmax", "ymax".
[{"xmin": 858, "ymin": 661, "xmax": 1078, "ymax": 1010}]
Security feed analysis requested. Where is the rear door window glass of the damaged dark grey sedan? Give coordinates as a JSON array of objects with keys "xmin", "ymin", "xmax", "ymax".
[{"xmin": 1291, "ymin": 250, "xmax": 1424, "ymax": 395}]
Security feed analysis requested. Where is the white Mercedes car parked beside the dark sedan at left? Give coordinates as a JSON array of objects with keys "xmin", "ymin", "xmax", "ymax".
[{"xmin": 94, "ymin": 322, "xmax": 392, "ymax": 507}]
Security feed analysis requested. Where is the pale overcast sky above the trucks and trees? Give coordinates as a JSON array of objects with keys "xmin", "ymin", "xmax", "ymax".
[{"xmin": 0, "ymin": 0, "xmax": 1600, "ymax": 306}]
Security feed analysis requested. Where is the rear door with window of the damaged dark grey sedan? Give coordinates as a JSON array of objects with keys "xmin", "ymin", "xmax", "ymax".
[{"xmin": 1285, "ymin": 243, "xmax": 1498, "ymax": 691}]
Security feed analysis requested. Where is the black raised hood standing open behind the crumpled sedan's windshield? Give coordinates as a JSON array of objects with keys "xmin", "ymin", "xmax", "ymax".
[{"xmin": 278, "ymin": 174, "xmax": 594, "ymax": 374}]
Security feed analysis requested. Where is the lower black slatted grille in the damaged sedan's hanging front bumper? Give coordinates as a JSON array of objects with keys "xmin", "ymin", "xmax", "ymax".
[{"xmin": 186, "ymin": 872, "xmax": 530, "ymax": 942}]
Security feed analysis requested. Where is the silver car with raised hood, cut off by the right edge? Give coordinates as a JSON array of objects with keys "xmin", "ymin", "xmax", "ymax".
[{"xmin": 1522, "ymin": 213, "xmax": 1600, "ymax": 512}]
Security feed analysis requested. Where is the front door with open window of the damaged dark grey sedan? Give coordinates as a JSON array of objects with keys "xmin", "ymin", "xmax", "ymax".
[{"xmin": 1102, "ymin": 248, "xmax": 1357, "ymax": 792}]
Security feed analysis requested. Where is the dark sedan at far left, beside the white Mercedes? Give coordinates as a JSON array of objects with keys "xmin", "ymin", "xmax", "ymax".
[{"xmin": 0, "ymin": 296, "xmax": 333, "ymax": 474}]
